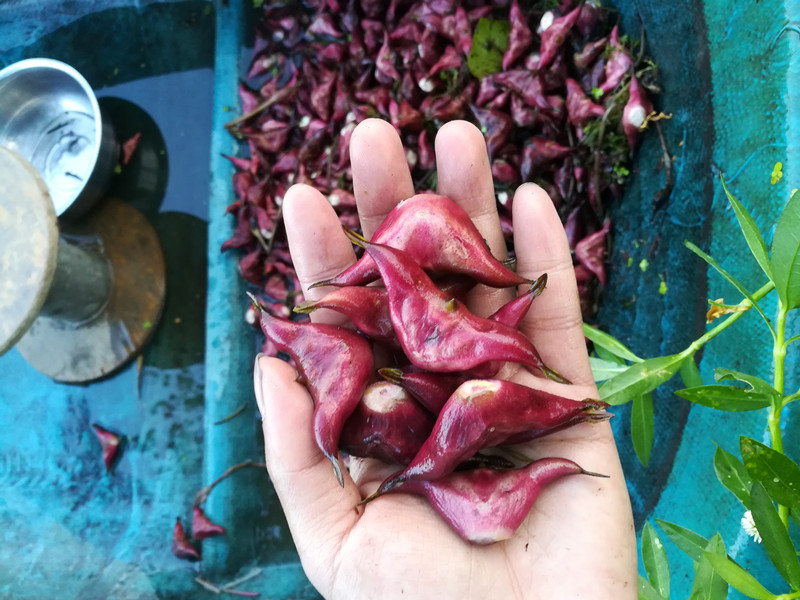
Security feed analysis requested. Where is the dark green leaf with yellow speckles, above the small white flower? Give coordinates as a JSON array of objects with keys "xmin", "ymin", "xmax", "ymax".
[{"xmin": 739, "ymin": 437, "xmax": 800, "ymax": 509}]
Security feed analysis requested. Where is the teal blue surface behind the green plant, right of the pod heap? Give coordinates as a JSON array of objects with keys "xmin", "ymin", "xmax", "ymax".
[{"xmin": 600, "ymin": 0, "xmax": 800, "ymax": 598}]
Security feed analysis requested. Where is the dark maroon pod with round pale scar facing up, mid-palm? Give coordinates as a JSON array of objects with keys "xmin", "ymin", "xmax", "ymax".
[{"xmin": 339, "ymin": 381, "xmax": 434, "ymax": 466}]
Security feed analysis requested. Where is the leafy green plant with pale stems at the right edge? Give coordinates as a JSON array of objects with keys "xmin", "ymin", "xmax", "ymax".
[{"xmin": 584, "ymin": 176, "xmax": 800, "ymax": 600}]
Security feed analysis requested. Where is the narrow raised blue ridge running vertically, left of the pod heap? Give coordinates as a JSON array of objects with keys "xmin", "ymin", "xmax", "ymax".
[{"xmin": 203, "ymin": 2, "xmax": 316, "ymax": 598}]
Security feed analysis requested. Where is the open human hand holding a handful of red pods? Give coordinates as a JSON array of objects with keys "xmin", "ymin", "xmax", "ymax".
[{"xmin": 255, "ymin": 120, "xmax": 637, "ymax": 600}]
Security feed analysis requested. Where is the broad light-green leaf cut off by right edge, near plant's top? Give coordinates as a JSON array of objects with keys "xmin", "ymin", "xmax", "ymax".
[{"xmin": 772, "ymin": 190, "xmax": 800, "ymax": 309}]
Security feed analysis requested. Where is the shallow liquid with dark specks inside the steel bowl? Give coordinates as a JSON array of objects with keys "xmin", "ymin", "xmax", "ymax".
[{"xmin": 31, "ymin": 111, "xmax": 97, "ymax": 213}]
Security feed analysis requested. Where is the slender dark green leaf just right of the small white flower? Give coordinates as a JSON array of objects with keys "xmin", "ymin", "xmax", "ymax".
[{"xmin": 750, "ymin": 481, "xmax": 800, "ymax": 590}]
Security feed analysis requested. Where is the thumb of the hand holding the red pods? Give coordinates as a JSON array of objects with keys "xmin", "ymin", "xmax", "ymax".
[{"xmin": 254, "ymin": 356, "xmax": 361, "ymax": 590}]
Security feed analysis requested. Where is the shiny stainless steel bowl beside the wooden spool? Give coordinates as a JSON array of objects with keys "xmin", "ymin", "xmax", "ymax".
[{"xmin": 0, "ymin": 58, "xmax": 119, "ymax": 219}]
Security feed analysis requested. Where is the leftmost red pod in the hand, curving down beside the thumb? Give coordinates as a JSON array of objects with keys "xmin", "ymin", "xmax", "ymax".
[{"xmin": 250, "ymin": 296, "xmax": 373, "ymax": 486}]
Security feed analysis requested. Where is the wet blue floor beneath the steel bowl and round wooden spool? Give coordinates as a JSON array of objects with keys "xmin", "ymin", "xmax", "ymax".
[{"xmin": 0, "ymin": 1, "xmax": 219, "ymax": 600}]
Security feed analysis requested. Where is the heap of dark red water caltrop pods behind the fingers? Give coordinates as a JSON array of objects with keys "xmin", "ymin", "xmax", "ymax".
[{"xmin": 222, "ymin": 0, "xmax": 673, "ymax": 342}]
